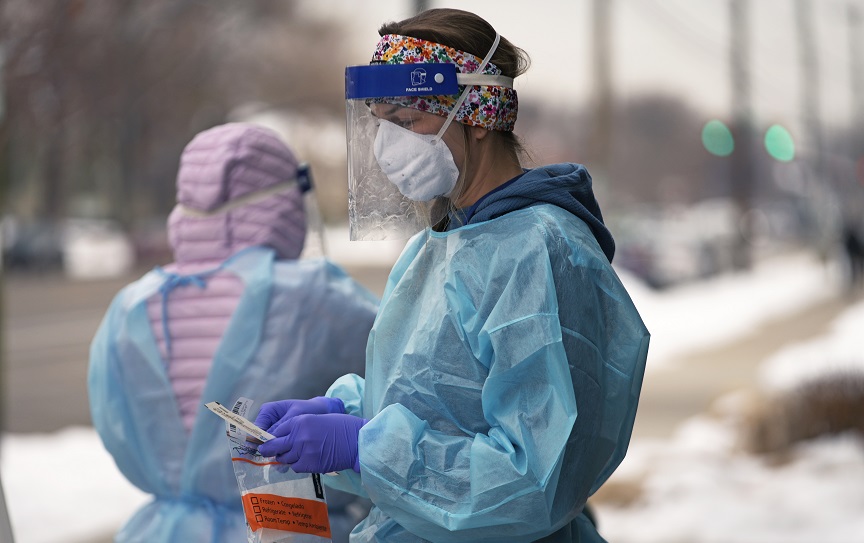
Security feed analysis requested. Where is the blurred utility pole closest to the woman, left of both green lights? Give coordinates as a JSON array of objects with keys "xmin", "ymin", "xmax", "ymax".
[{"xmin": 591, "ymin": 0, "xmax": 614, "ymax": 185}]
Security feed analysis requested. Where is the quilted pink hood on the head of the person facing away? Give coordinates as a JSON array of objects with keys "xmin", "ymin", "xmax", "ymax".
[{"xmin": 168, "ymin": 123, "xmax": 306, "ymax": 263}]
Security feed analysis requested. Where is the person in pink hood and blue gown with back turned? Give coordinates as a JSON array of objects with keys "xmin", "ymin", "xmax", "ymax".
[{"xmin": 88, "ymin": 123, "xmax": 377, "ymax": 543}]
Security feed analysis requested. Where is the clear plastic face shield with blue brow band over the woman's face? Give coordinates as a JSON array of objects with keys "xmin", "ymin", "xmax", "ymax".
[{"xmin": 345, "ymin": 63, "xmax": 459, "ymax": 241}]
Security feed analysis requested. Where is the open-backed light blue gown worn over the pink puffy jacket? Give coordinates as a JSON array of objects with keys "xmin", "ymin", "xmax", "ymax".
[{"xmin": 88, "ymin": 248, "xmax": 377, "ymax": 543}]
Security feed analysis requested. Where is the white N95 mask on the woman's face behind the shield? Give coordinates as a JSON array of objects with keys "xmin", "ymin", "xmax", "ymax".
[{"xmin": 373, "ymin": 119, "xmax": 459, "ymax": 202}]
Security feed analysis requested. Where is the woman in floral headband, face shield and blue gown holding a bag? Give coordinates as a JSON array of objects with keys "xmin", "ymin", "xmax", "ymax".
[{"xmin": 256, "ymin": 9, "xmax": 649, "ymax": 543}]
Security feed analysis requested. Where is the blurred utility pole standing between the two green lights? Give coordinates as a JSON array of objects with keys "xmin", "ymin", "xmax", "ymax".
[{"xmin": 729, "ymin": 0, "xmax": 756, "ymax": 269}]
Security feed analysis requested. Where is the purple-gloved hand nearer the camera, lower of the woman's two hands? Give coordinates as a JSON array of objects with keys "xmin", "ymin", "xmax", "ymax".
[{"xmin": 258, "ymin": 414, "xmax": 369, "ymax": 473}]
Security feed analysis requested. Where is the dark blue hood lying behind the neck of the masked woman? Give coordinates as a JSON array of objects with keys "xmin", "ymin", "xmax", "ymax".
[{"xmin": 460, "ymin": 163, "xmax": 615, "ymax": 263}]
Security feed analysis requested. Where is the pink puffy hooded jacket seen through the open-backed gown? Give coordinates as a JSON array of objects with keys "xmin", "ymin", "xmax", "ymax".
[{"xmin": 147, "ymin": 123, "xmax": 306, "ymax": 430}]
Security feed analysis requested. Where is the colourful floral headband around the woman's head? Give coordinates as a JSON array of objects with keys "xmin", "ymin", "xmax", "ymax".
[{"xmin": 371, "ymin": 34, "xmax": 519, "ymax": 132}]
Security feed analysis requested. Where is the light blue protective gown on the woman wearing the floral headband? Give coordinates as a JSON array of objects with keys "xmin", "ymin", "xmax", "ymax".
[{"xmin": 324, "ymin": 167, "xmax": 649, "ymax": 543}]
